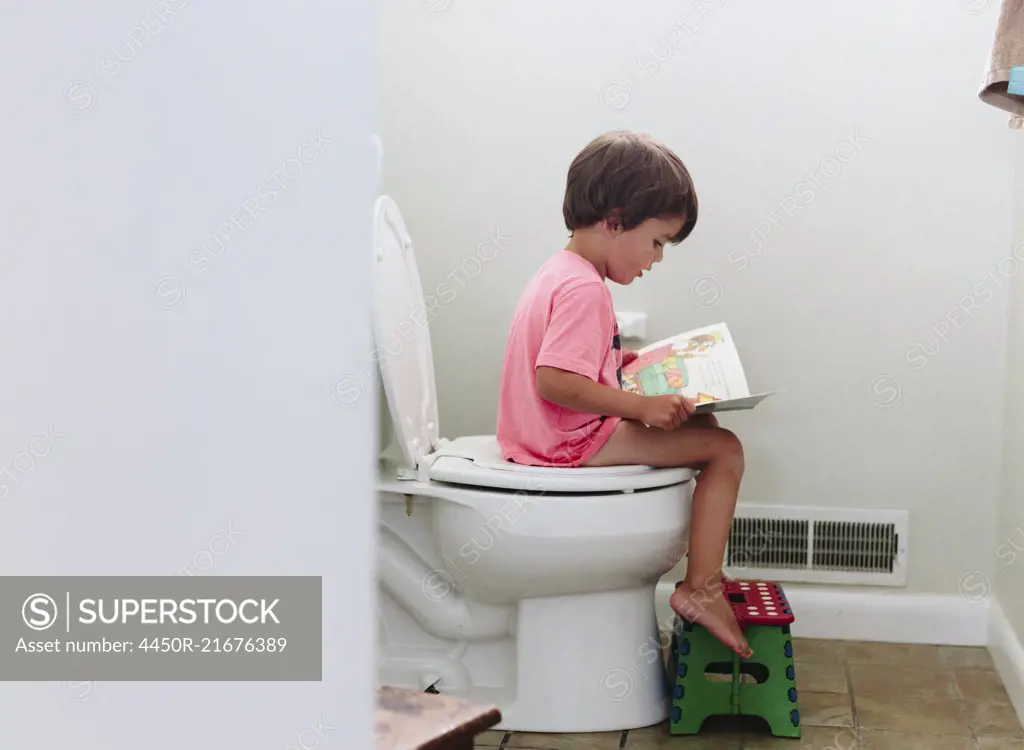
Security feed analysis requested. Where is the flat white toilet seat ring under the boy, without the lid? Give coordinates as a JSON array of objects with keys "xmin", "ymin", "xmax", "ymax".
[{"xmin": 425, "ymin": 435, "xmax": 694, "ymax": 494}]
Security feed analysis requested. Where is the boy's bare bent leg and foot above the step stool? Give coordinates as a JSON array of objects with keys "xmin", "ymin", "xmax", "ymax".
[{"xmin": 587, "ymin": 417, "xmax": 753, "ymax": 659}]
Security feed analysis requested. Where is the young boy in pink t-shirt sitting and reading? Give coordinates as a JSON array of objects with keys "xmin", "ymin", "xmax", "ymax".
[{"xmin": 497, "ymin": 131, "xmax": 752, "ymax": 658}]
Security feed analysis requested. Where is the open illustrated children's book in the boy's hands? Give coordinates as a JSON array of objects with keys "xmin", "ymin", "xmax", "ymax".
[{"xmin": 623, "ymin": 323, "xmax": 775, "ymax": 414}]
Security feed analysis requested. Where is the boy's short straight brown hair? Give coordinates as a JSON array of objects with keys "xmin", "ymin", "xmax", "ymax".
[{"xmin": 562, "ymin": 130, "xmax": 697, "ymax": 244}]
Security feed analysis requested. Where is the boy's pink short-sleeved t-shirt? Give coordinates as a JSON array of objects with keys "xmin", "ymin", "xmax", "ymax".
[{"xmin": 498, "ymin": 250, "xmax": 623, "ymax": 466}]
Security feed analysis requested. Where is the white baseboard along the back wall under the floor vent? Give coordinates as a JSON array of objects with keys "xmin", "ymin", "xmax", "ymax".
[{"xmin": 655, "ymin": 581, "xmax": 991, "ymax": 643}]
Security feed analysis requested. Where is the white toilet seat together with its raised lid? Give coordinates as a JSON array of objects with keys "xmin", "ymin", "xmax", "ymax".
[{"xmin": 372, "ymin": 196, "xmax": 694, "ymax": 494}]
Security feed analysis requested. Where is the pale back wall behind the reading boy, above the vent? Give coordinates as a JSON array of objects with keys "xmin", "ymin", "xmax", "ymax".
[{"xmin": 378, "ymin": 0, "xmax": 1013, "ymax": 593}]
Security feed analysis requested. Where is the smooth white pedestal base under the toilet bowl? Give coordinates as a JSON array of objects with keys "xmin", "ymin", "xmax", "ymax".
[{"xmin": 495, "ymin": 581, "xmax": 670, "ymax": 733}]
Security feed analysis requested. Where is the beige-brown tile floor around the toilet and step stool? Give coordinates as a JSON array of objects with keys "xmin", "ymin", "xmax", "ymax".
[{"xmin": 476, "ymin": 638, "xmax": 1024, "ymax": 750}]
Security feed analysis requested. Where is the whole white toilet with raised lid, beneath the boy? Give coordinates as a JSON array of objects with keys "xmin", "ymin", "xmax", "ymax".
[{"xmin": 374, "ymin": 197, "xmax": 694, "ymax": 733}]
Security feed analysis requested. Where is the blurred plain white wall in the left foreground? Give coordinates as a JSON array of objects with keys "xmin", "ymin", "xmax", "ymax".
[{"xmin": 0, "ymin": 0, "xmax": 375, "ymax": 750}]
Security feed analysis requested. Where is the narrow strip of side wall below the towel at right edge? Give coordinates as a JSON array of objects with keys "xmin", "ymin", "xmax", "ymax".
[{"xmin": 995, "ymin": 133, "xmax": 1024, "ymax": 642}]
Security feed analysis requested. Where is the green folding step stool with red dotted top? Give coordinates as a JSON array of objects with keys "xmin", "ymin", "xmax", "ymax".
[{"xmin": 668, "ymin": 581, "xmax": 801, "ymax": 738}]
